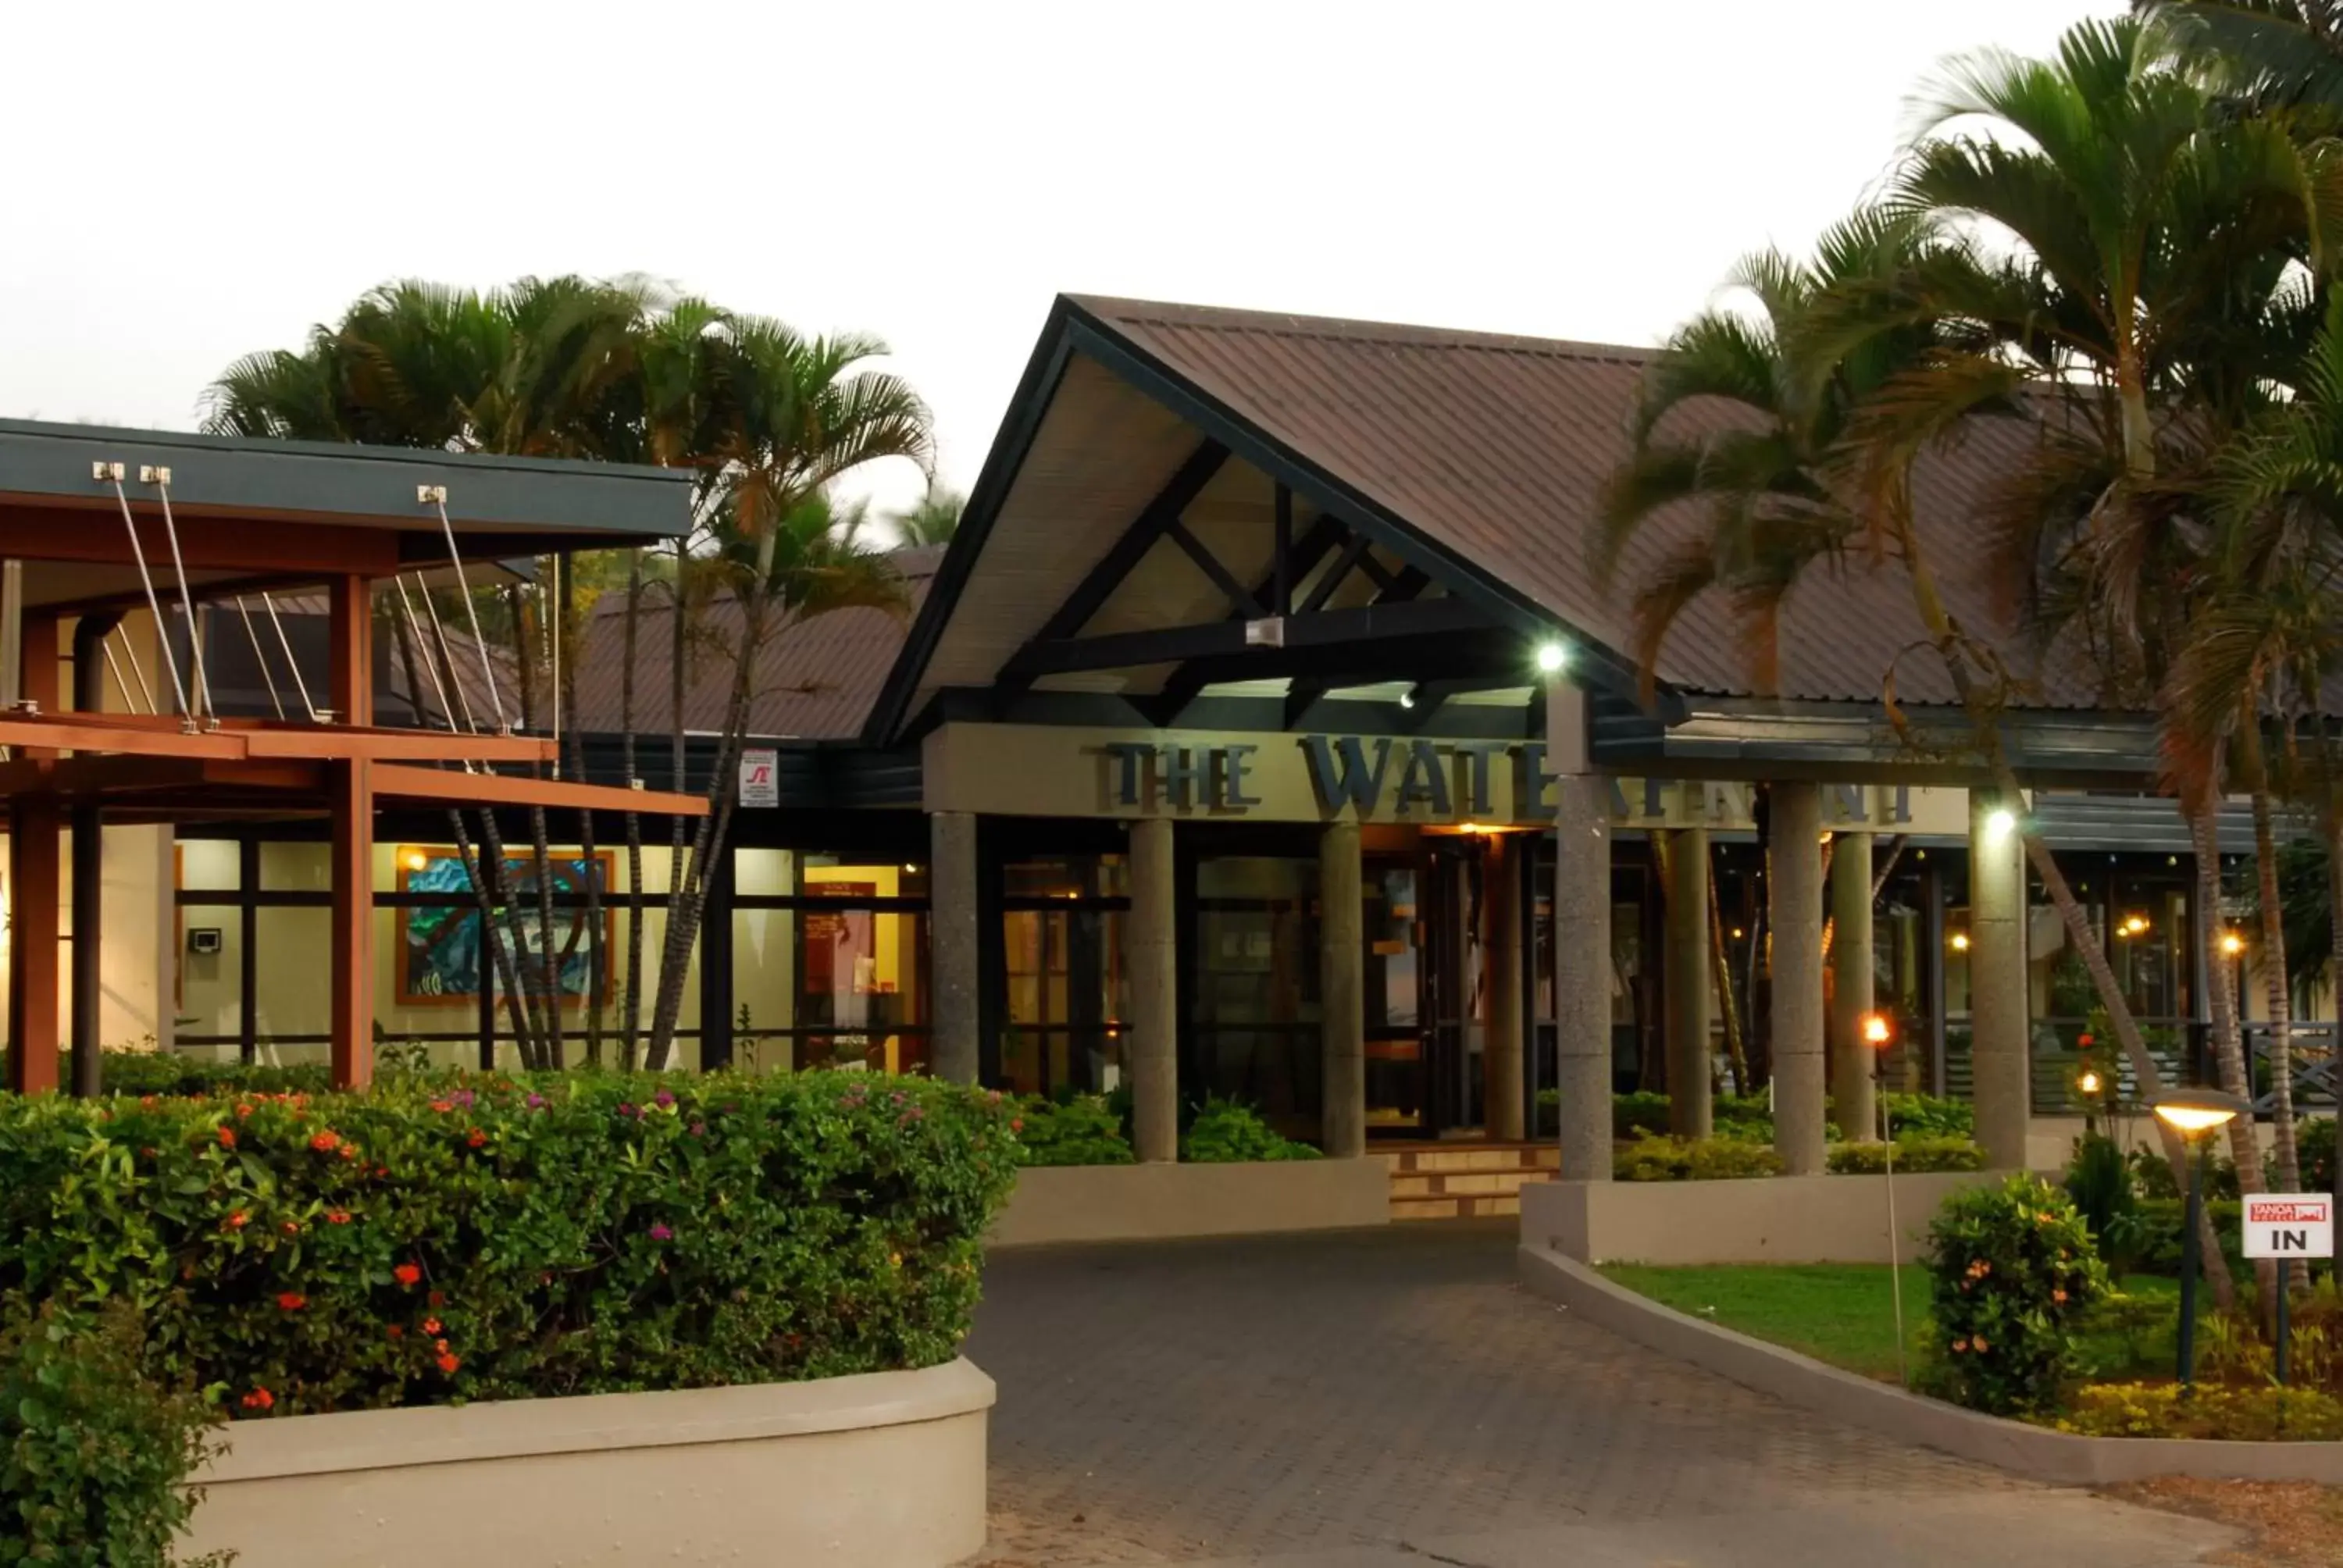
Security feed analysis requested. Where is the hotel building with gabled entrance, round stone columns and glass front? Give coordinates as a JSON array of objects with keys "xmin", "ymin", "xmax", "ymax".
[{"xmin": 12, "ymin": 298, "xmax": 2306, "ymax": 1167}]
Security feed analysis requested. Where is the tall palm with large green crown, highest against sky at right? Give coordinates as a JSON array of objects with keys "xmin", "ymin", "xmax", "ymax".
[{"xmin": 1835, "ymin": 19, "xmax": 2322, "ymax": 1209}]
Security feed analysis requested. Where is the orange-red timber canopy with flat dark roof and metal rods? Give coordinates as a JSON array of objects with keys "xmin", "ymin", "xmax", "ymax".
[{"xmin": 0, "ymin": 422, "xmax": 708, "ymax": 1090}]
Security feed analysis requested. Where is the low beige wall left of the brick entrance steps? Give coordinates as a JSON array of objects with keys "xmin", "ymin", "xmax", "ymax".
[{"xmin": 986, "ymin": 1160, "xmax": 1392, "ymax": 1247}]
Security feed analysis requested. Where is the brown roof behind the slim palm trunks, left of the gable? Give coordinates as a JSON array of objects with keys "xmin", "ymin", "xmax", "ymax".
[{"xmin": 569, "ymin": 546, "xmax": 944, "ymax": 740}]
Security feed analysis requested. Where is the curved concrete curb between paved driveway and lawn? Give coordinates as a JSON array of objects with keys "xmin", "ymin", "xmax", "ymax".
[{"xmin": 1516, "ymin": 1245, "xmax": 2343, "ymax": 1486}]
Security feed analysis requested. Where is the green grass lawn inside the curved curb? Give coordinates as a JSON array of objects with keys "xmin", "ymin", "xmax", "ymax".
[{"xmin": 1603, "ymin": 1263, "xmax": 2179, "ymax": 1383}]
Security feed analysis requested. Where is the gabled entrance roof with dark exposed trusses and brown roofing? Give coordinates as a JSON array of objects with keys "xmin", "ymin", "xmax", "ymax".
[{"xmin": 865, "ymin": 295, "xmax": 2158, "ymax": 788}]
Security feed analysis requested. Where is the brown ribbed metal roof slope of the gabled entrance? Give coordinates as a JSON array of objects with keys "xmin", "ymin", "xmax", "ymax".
[{"xmin": 1071, "ymin": 298, "xmax": 2092, "ymax": 705}]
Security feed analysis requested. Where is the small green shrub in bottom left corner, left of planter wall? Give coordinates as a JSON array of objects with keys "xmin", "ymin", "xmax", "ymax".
[{"xmin": 0, "ymin": 1303, "xmax": 225, "ymax": 1568}]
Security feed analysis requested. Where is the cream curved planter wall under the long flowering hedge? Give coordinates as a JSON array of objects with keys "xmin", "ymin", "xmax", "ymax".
[{"xmin": 185, "ymin": 1362, "xmax": 993, "ymax": 1568}]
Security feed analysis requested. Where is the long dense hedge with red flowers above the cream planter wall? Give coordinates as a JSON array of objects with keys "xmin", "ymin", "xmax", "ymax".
[{"xmin": 0, "ymin": 1074, "xmax": 1015, "ymax": 1416}]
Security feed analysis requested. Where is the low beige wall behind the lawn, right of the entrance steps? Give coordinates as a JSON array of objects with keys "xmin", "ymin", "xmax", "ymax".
[{"xmin": 1521, "ymin": 1172, "xmax": 1996, "ymax": 1263}]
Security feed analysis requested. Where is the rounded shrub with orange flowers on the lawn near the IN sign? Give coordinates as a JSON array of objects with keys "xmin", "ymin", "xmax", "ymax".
[{"xmin": 1928, "ymin": 1174, "xmax": 2106, "ymax": 1416}]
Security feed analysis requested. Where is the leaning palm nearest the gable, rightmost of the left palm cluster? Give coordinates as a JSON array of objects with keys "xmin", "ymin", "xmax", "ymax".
[{"xmin": 651, "ymin": 316, "xmax": 935, "ymax": 1062}]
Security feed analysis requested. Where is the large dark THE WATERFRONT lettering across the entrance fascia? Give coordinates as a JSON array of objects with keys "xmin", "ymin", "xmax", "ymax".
[{"xmin": 1097, "ymin": 736, "xmax": 1912, "ymax": 830}]
